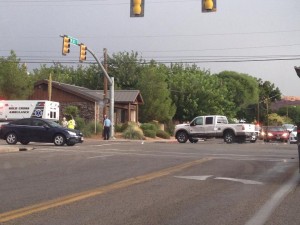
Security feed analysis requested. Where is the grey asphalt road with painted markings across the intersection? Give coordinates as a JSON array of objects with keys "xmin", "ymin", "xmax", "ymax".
[{"xmin": 0, "ymin": 140, "xmax": 300, "ymax": 225}]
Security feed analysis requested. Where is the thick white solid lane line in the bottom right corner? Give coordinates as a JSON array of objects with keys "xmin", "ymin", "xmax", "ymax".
[{"xmin": 245, "ymin": 170, "xmax": 299, "ymax": 225}]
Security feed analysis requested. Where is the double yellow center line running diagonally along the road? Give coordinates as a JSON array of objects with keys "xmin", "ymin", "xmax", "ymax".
[{"xmin": 0, "ymin": 158, "xmax": 212, "ymax": 222}]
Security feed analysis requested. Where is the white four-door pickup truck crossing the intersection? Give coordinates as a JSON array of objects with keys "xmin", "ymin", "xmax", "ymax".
[{"xmin": 175, "ymin": 115, "xmax": 257, "ymax": 143}]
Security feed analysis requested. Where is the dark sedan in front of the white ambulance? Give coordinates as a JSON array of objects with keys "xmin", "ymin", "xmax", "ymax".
[{"xmin": 0, "ymin": 118, "xmax": 83, "ymax": 146}]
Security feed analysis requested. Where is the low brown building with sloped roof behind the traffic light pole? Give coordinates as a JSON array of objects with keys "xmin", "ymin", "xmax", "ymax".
[{"xmin": 30, "ymin": 80, "xmax": 144, "ymax": 124}]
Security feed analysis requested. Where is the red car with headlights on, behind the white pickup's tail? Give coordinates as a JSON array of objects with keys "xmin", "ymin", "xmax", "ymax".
[{"xmin": 261, "ymin": 126, "xmax": 289, "ymax": 142}]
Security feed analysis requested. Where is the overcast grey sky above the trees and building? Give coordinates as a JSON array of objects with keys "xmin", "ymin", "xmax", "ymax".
[{"xmin": 0, "ymin": 0, "xmax": 300, "ymax": 96}]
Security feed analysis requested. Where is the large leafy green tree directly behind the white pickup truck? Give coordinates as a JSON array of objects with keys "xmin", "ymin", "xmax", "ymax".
[{"xmin": 169, "ymin": 64, "xmax": 235, "ymax": 121}]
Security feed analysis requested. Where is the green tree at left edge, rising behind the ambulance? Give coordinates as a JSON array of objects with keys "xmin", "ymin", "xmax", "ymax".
[{"xmin": 0, "ymin": 51, "xmax": 33, "ymax": 100}]
